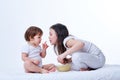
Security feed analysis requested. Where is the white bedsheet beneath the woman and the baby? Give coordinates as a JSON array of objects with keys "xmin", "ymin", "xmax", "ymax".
[{"xmin": 0, "ymin": 65, "xmax": 120, "ymax": 80}]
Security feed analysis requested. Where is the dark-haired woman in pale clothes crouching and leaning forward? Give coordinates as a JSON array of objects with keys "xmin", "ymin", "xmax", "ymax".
[{"xmin": 49, "ymin": 23, "xmax": 105, "ymax": 71}]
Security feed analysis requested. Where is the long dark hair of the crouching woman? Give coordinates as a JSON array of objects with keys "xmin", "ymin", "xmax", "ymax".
[{"xmin": 50, "ymin": 23, "xmax": 69, "ymax": 55}]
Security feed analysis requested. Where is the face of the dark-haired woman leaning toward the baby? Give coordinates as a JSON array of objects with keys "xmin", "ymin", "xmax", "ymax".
[{"xmin": 49, "ymin": 28, "xmax": 57, "ymax": 45}]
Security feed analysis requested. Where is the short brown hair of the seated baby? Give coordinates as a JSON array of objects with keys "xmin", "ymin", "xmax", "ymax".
[{"xmin": 24, "ymin": 26, "xmax": 43, "ymax": 41}]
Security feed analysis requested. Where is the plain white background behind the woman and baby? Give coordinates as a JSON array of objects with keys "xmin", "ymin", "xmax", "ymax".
[{"xmin": 0, "ymin": 0, "xmax": 120, "ymax": 72}]
